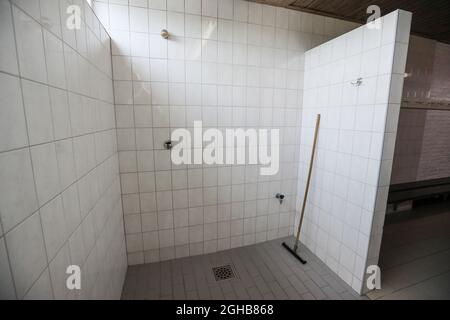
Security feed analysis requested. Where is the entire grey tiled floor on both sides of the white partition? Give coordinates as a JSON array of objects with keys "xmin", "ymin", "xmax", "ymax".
[{"xmin": 122, "ymin": 204, "xmax": 450, "ymax": 299}]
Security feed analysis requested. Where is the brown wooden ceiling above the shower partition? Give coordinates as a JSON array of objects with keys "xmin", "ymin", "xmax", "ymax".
[{"xmin": 250, "ymin": 0, "xmax": 450, "ymax": 43}]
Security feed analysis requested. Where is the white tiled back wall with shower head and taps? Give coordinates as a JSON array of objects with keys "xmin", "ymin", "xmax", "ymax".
[{"xmin": 90, "ymin": 0, "xmax": 355, "ymax": 264}]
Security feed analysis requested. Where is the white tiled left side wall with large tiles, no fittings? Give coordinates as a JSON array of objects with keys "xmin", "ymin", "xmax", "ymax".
[{"xmin": 0, "ymin": 0, "xmax": 127, "ymax": 299}]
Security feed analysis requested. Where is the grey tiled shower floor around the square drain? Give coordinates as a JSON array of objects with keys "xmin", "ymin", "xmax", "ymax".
[{"xmin": 122, "ymin": 238, "xmax": 366, "ymax": 299}]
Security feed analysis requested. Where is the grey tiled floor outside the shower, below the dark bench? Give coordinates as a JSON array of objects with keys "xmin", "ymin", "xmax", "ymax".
[{"xmin": 367, "ymin": 202, "xmax": 450, "ymax": 299}]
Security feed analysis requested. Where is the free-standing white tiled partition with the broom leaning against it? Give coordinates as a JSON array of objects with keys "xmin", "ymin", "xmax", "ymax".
[{"xmin": 298, "ymin": 10, "xmax": 411, "ymax": 293}]
